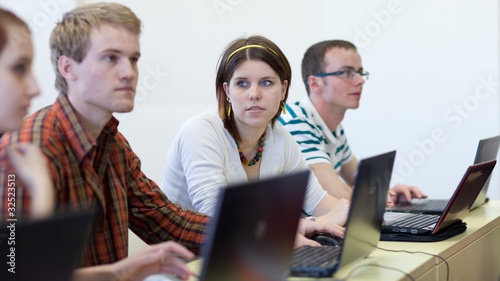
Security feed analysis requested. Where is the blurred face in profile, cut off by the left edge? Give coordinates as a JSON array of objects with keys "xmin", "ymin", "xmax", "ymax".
[{"xmin": 0, "ymin": 24, "xmax": 40, "ymax": 133}]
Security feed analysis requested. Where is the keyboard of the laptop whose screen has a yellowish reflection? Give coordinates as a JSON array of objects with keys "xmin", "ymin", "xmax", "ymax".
[{"xmin": 291, "ymin": 246, "xmax": 342, "ymax": 277}]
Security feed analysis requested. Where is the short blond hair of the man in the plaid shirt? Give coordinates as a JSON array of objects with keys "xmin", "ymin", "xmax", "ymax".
[{"xmin": 50, "ymin": 2, "xmax": 141, "ymax": 93}]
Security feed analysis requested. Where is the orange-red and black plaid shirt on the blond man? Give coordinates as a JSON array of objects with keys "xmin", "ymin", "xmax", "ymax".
[{"xmin": 0, "ymin": 95, "xmax": 208, "ymax": 266}]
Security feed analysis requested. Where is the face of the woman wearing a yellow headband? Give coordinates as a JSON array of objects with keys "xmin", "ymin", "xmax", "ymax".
[{"xmin": 224, "ymin": 60, "xmax": 288, "ymax": 131}]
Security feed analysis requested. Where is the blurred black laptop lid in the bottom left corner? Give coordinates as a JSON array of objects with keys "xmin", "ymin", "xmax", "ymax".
[{"xmin": 0, "ymin": 211, "xmax": 91, "ymax": 281}]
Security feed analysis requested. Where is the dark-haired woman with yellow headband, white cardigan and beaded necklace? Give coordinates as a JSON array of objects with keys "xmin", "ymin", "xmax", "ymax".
[{"xmin": 162, "ymin": 36, "xmax": 349, "ymax": 245}]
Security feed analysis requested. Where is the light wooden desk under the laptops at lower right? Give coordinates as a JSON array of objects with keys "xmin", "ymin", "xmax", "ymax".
[{"xmin": 290, "ymin": 201, "xmax": 500, "ymax": 281}]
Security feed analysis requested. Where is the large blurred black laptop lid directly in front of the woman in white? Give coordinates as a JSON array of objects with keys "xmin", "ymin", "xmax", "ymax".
[{"xmin": 200, "ymin": 170, "xmax": 310, "ymax": 281}]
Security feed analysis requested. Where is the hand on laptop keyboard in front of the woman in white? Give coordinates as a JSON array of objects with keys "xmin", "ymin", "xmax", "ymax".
[{"xmin": 295, "ymin": 219, "xmax": 344, "ymax": 247}]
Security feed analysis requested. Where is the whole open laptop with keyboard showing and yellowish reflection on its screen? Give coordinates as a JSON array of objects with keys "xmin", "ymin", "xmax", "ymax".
[{"xmin": 291, "ymin": 151, "xmax": 396, "ymax": 277}]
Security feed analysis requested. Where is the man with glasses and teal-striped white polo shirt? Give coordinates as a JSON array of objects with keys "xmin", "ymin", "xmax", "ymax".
[{"xmin": 280, "ymin": 40, "xmax": 427, "ymax": 203}]
